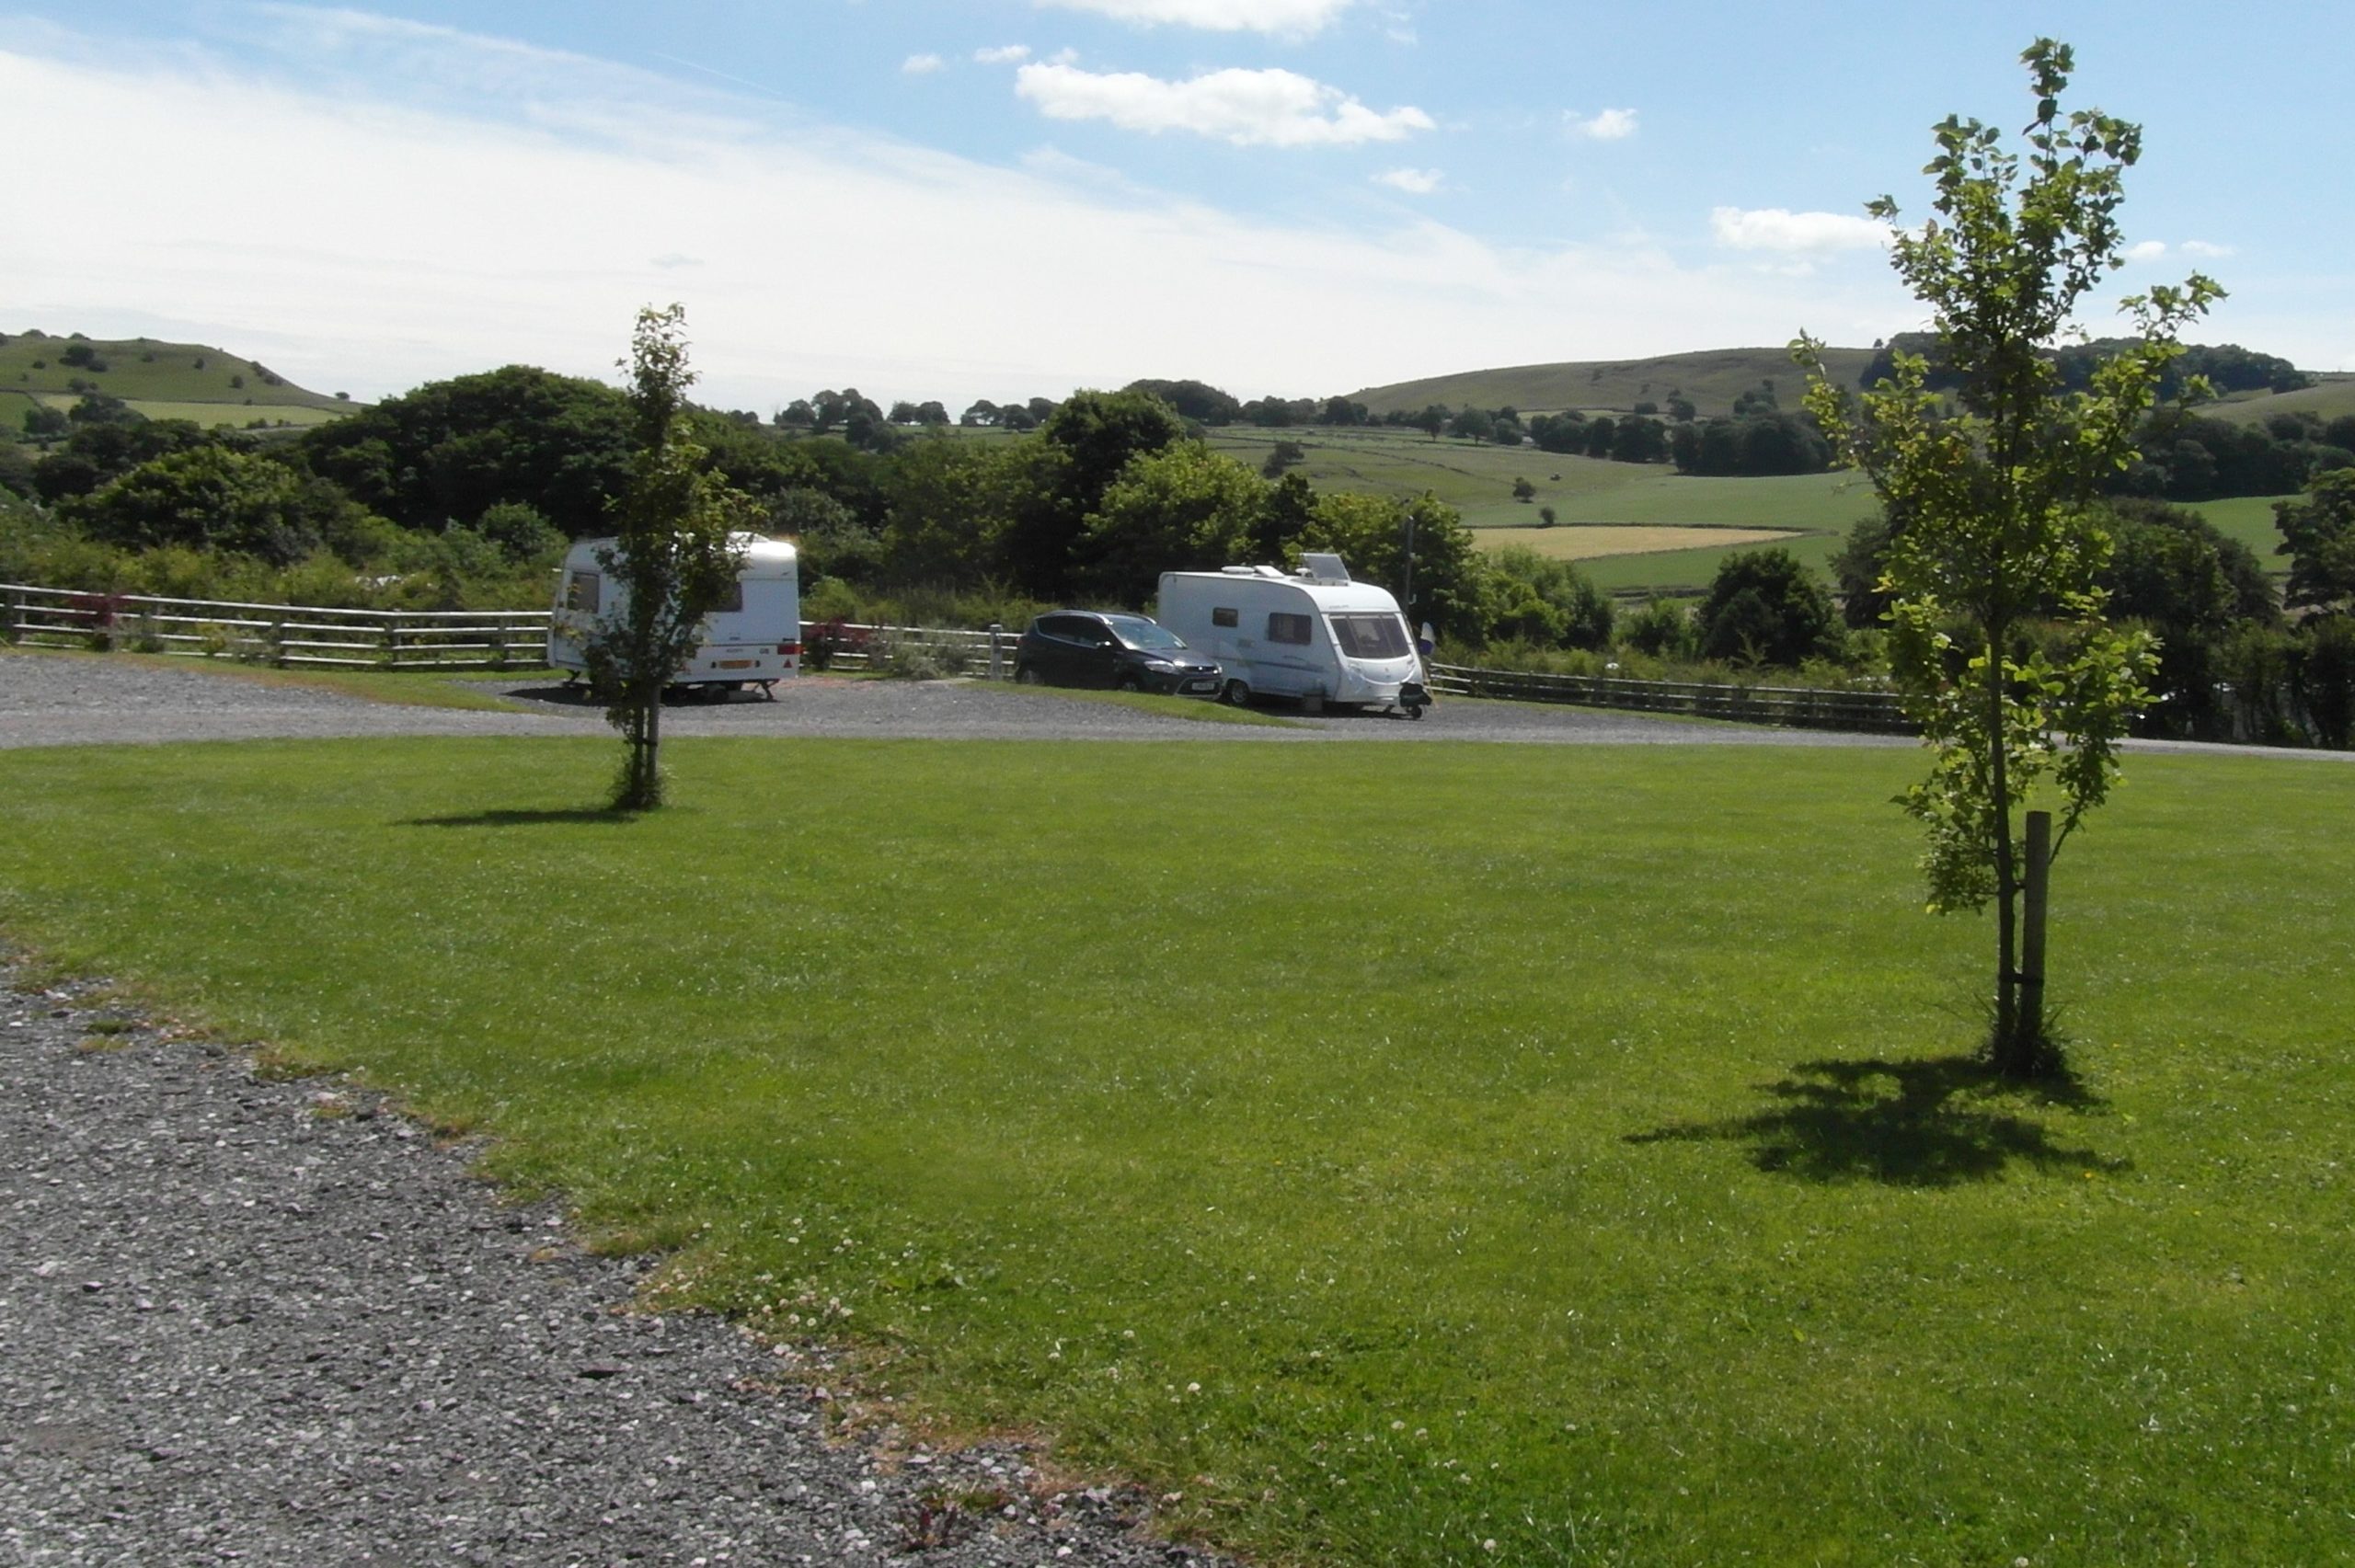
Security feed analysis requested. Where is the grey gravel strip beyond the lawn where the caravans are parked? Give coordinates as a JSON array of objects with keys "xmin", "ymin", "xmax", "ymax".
[{"xmin": 0, "ymin": 652, "xmax": 1910, "ymax": 749}]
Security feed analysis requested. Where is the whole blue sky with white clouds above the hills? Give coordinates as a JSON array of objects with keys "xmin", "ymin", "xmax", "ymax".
[{"xmin": 0, "ymin": 0, "xmax": 2355, "ymax": 412}]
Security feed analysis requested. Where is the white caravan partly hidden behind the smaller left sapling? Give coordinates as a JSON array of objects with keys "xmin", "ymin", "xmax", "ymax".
[{"xmin": 548, "ymin": 534, "xmax": 800, "ymax": 694}]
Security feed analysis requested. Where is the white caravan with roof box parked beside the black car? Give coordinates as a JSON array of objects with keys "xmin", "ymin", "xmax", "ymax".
[{"xmin": 1154, "ymin": 555, "xmax": 1431, "ymax": 718}]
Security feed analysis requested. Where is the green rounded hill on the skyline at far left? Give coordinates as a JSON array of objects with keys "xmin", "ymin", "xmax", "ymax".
[{"xmin": 0, "ymin": 332, "xmax": 353, "ymax": 429}]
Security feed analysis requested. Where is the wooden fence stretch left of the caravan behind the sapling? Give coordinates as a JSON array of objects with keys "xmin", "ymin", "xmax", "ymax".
[{"xmin": 0, "ymin": 581, "xmax": 548, "ymax": 669}]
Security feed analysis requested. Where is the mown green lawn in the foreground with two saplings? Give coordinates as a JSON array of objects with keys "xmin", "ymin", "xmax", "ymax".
[{"xmin": 0, "ymin": 739, "xmax": 2355, "ymax": 1565}]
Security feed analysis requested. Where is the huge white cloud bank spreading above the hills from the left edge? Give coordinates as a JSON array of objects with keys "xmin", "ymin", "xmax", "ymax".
[{"xmin": 0, "ymin": 30, "xmax": 1949, "ymax": 407}]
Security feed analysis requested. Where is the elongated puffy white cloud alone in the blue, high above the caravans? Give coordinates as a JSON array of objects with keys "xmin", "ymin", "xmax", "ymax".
[{"xmin": 1015, "ymin": 66, "xmax": 1431, "ymax": 146}]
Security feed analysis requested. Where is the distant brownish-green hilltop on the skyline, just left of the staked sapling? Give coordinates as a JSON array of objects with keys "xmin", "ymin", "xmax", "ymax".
[{"xmin": 1350, "ymin": 349, "xmax": 1875, "ymax": 417}]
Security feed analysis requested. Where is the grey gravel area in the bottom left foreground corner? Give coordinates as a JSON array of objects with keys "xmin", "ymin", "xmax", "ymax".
[{"xmin": 0, "ymin": 963, "xmax": 1212, "ymax": 1568}]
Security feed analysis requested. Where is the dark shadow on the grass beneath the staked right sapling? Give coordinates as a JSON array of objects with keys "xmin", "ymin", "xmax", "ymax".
[{"xmin": 1627, "ymin": 1057, "xmax": 2127, "ymax": 1186}]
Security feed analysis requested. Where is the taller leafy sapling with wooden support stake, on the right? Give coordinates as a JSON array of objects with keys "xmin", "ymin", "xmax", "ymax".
[{"xmin": 1792, "ymin": 38, "xmax": 2223, "ymax": 1079}]
